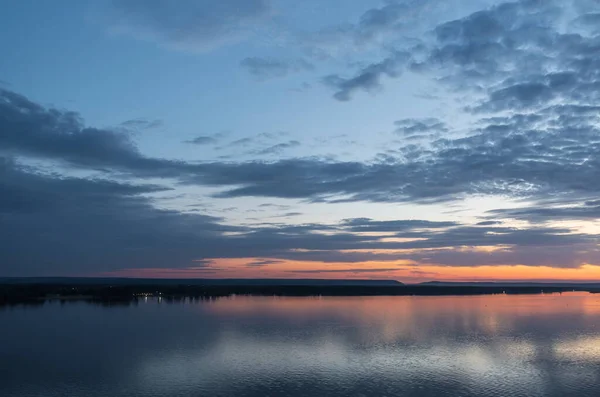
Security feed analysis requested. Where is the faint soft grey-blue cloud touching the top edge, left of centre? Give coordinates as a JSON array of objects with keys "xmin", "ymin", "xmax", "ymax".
[{"xmin": 110, "ymin": 0, "xmax": 272, "ymax": 50}]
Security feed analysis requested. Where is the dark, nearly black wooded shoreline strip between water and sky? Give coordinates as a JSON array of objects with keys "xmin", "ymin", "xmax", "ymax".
[{"xmin": 0, "ymin": 280, "xmax": 600, "ymax": 305}]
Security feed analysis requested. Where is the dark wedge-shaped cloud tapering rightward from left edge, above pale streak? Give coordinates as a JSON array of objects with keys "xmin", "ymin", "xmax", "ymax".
[{"xmin": 0, "ymin": 89, "xmax": 186, "ymax": 176}]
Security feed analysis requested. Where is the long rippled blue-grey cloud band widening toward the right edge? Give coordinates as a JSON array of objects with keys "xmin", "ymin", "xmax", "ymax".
[{"xmin": 193, "ymin": 103, "xmax": 600, "ymax": 201}]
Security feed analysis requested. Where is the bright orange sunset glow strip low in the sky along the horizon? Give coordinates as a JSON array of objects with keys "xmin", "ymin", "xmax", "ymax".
[{"xmin": 99, "ymin": 258, "xmax": 600, "ymax": 283}]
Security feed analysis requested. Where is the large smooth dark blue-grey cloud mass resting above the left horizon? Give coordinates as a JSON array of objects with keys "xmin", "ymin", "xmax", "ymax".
[{"xmin": 0, "ymin": 159, "xmax": 231, "ymax": 275}]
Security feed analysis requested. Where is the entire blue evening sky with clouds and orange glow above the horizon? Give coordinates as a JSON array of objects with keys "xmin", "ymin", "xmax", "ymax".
[{"xmin": 0, "ymin": 0, "xmax": 600, "ymax": 283}]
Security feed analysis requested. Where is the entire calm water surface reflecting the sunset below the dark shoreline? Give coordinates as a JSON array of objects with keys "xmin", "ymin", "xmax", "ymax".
[{"xmin": 0, "ymin": 294, "xmax": 600, "ymax": 397}]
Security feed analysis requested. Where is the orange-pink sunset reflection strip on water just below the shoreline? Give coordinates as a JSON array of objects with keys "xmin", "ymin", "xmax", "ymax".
[{"xmin": 204, "ymin": 292, "xmax": 600, "ymax": 342}]
